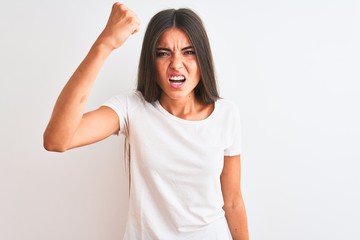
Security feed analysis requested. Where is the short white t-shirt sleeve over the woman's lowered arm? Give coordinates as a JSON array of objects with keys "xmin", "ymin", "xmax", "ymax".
[{"xmin": 224, "ymin": 104, "xmax": 242, "ymax": 156}]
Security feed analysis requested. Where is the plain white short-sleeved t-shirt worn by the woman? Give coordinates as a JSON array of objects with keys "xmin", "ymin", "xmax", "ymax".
[{"xmin": 104, "ymin": 92, "xmax": 241, "ymax": 240}]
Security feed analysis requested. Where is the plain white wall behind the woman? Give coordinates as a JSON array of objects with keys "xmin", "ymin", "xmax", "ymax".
[{"xmin": 0, "ymin": 0, "xmax": 360, "ymax": 240}]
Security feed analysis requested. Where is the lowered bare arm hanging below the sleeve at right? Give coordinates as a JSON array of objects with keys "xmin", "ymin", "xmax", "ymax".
[{"xmin": 221, "ymin": 155, "xmax": 249, "ymax": 240}]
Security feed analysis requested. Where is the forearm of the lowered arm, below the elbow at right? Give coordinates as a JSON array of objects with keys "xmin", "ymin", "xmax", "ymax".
[{"xmin": 224, "ymin": 200, "xmax": 249, "ymax": 240}]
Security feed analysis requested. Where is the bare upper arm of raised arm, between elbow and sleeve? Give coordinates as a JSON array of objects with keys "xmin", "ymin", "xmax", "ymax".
[{"xmin": 69, "ymin": 106, "xmax": 120, "ymax": 149}]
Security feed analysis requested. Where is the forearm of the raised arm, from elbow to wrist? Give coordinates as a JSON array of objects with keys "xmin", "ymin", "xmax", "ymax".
[{"xmin": 44, "ymin": 41, "xmax": 111, "ymax": 151}]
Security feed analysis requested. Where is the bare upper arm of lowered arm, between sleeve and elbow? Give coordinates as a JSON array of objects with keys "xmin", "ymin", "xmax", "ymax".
[{"xmin": 220, "ymin": 155, "xmax": 242, "ymax": 207}]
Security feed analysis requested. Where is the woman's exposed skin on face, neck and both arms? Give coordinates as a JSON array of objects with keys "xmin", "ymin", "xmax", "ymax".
[{"xmin": 44, "ymin": 3, "xmax": 248, "ymax": 240}]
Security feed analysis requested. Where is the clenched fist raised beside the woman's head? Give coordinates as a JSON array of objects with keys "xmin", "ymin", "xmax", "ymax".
[{"xmin": 97, "ymin": 2, "xmax": 140, "ymax": 50}]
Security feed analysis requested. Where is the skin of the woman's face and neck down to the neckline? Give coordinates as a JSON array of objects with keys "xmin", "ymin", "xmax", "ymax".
[{"xmin": 156, "ymin": 28, "xmax": 214, "ymax": 120}]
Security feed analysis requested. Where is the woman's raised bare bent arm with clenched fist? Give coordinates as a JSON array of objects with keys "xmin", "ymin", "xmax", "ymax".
[{"xmin": 44, "ymin": 2, "xmax": 140, "ymax": 152}]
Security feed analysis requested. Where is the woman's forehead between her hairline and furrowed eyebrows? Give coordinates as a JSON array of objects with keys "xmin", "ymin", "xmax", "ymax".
[{"xmin": 157, "ymin": 27, "xmax": 192, "ymax": 47}]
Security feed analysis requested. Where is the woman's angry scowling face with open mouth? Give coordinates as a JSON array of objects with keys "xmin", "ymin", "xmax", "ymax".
[{"xmin": 155, "ymin": 28, "xmax": 200, "ymax": 100}]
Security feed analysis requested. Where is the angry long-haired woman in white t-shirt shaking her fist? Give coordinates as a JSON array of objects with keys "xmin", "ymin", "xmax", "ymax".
[{"xmin": 44, "ymin": 3, "xmax": 248, "ymax": 240}]
